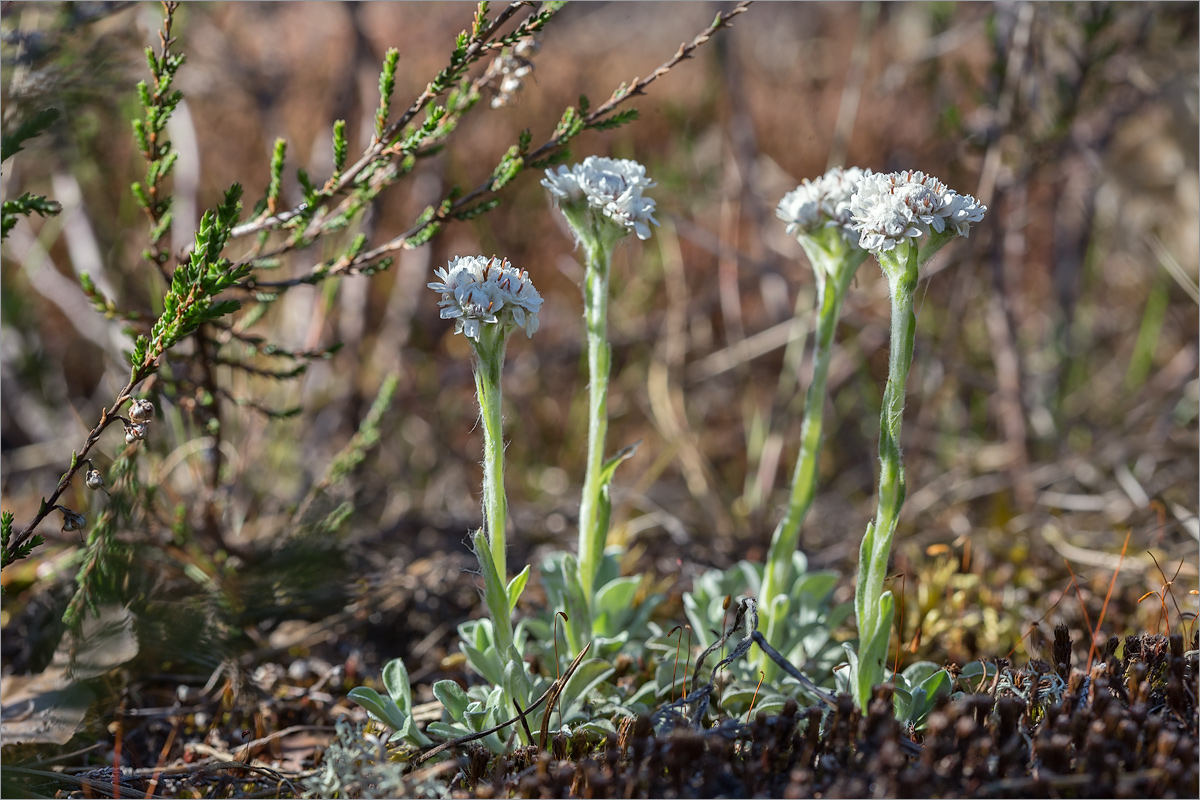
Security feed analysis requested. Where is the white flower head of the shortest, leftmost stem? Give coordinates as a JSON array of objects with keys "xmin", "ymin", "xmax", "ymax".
[{"xmin": 428, "ymin": 255, "xmax": 542, "ymax": 342}]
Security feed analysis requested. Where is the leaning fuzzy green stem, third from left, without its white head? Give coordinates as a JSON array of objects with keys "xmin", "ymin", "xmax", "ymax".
[{"xmin": 758, "ymin": 247, "xmax": 865, "ymax": 681}]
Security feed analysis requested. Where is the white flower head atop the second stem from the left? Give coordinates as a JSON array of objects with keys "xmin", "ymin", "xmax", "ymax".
[{"xmin": 541, "ymin": 156, "xmax": 659, "ymax": 239}]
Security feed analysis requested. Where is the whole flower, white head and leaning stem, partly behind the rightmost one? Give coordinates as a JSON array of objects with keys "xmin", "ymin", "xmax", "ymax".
[{"xmin": 758, "ymin": 167, "xmax": 866, "ymax": 680}]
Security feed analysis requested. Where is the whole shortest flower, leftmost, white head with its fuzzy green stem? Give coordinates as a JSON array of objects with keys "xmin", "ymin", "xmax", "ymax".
[{"xmin": 428, "ymin": 255, "xmax": 542, "ymax": 652}]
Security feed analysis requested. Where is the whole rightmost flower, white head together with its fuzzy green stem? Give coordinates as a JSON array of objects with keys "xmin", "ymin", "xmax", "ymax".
[{"xmin": 850, "ymin": 170, "xmax": 988, "ymax": 710}]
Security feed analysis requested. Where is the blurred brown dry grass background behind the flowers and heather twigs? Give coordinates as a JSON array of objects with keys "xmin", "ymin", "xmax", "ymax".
[{"xmin": 0, "ymin": 2, "xmax": 1200, "ymax": 671}]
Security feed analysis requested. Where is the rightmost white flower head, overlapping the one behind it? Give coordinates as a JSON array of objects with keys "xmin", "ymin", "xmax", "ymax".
[{"xmin": 850, "ymin": 169, "xmax": 988, "ymax": 253}]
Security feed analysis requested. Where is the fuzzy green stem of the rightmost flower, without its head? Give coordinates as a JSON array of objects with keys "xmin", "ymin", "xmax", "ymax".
[{"xmin": 854, "ymin": 246, "xmax": 918, "ymax": 710}]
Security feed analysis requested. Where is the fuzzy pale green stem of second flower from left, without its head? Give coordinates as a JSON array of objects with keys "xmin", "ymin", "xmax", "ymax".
[{"xmin": 578, "ymin": 235, "xmax": 612, "ymax": 613}]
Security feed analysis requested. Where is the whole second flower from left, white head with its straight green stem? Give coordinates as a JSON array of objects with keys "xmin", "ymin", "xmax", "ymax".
[{"xmin": 541, "ymin": 156, "xmax": 658, "ymax": 651}]
